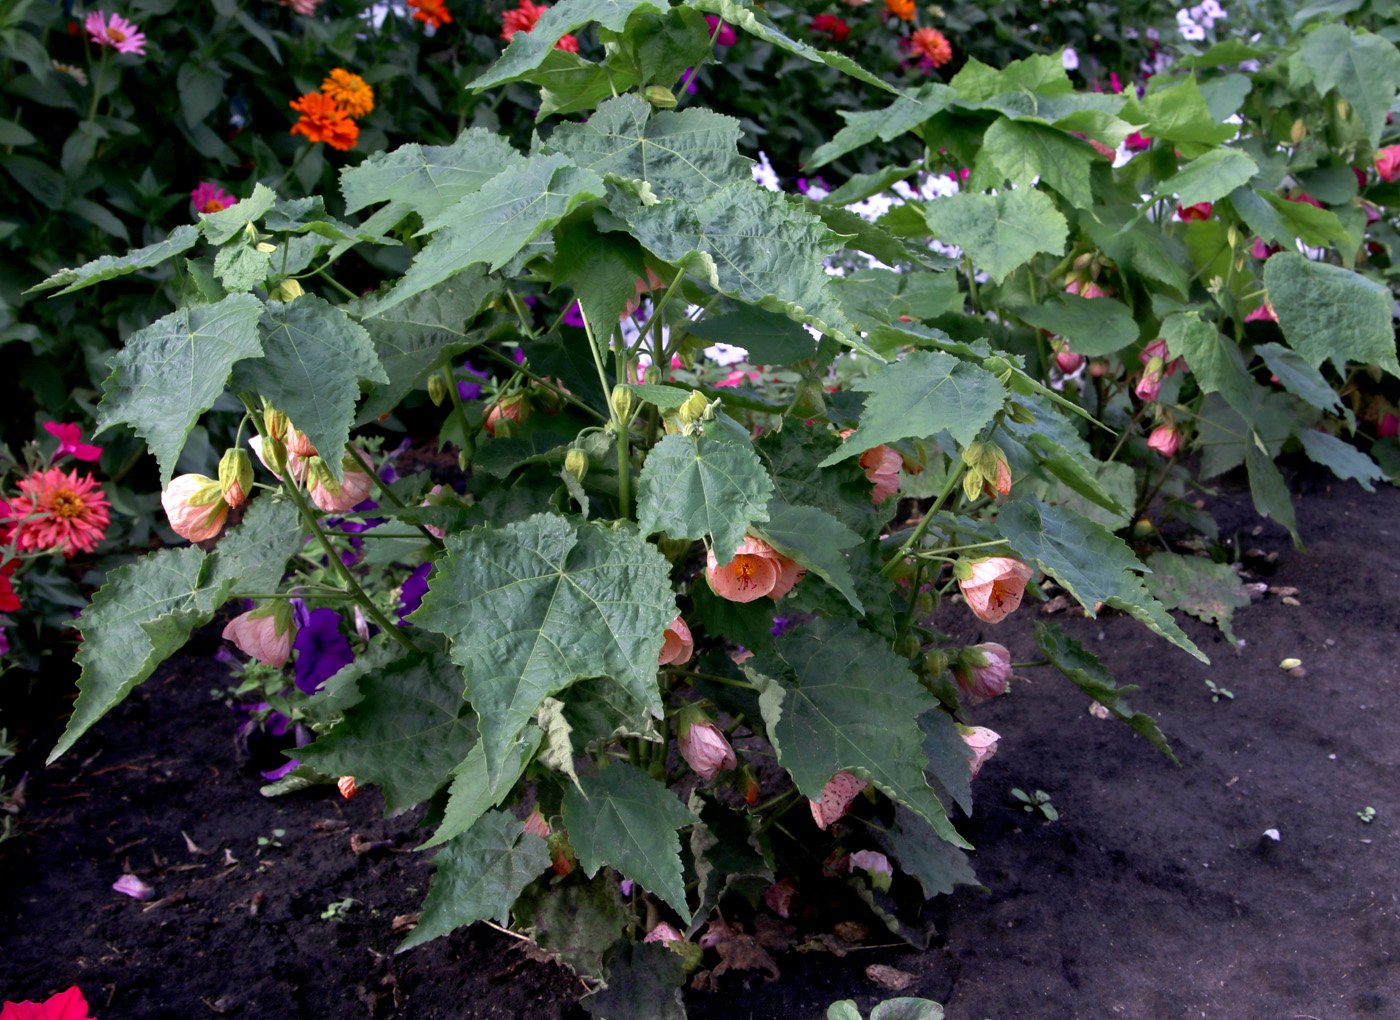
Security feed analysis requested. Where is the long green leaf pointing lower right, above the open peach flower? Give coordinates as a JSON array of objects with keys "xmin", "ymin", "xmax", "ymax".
[{"xmin": 997, "ymin": 500, "xmax": 1210, "ymax": 663}]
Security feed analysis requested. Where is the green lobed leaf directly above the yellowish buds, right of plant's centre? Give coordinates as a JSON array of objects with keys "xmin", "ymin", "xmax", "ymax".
[{"xmin": 822, "ymin": 351, "xmax": 1007, "ymax": 467}]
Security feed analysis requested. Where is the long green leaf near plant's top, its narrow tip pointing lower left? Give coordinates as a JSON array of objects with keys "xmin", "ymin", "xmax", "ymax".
[{"xmin": 368, "ymin": 153, "xmax": 603, "ymax": 315}]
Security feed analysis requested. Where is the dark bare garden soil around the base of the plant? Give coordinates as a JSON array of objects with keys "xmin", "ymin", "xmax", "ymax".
[{"xmin": 0, "ymin": 470, "xmax": 1400, "ymax": 1020}]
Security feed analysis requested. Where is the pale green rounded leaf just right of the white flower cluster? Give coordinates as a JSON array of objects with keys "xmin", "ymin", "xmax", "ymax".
[{"xmin": 924, "ymin": 187, "xmax": 1070, "ymax": 283}]
